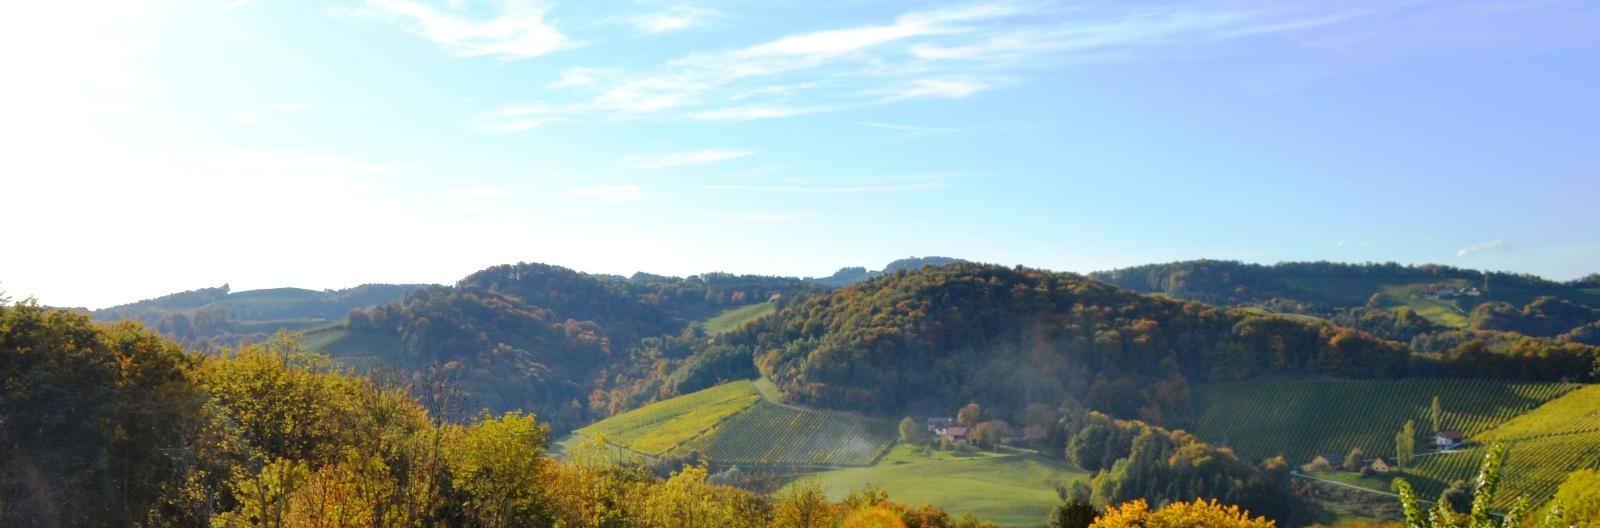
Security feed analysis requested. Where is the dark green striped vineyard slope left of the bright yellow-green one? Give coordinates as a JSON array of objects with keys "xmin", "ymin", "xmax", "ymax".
[{"xmin": 1192, "ymin": 379, "xmax": 1579, "ymax": 464}]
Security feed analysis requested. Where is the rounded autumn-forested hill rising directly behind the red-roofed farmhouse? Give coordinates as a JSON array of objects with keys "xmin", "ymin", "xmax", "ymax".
[{"xmin": 718, "ymin": 264, "xmax": 1410, "ymax": 422}]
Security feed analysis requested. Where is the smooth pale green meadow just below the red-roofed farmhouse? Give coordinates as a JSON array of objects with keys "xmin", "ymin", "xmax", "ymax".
[{"xmin": 793, "ymin": 445, "xmax": 1088, "ymax": 526}]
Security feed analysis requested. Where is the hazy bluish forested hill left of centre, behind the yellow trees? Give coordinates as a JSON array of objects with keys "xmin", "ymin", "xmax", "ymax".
[{"xmin": 340, "ymin": 264, "xmax": 826, "ymax": 430}]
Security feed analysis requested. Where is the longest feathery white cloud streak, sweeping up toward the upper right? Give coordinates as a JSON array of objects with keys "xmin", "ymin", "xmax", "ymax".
[{"xmin": 483, "ymin": 0, "xmax": 1365, "ymax": 130}]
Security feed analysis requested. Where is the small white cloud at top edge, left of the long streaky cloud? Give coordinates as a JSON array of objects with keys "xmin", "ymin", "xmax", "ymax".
[{"xmin": 366, "ymin": 0, "xmax": 584, "ymax": 61}]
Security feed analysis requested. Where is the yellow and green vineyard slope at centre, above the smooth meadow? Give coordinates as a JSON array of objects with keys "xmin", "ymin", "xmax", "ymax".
[{"xmin": 574, "ymin": 381, "xmax": 898, "ymax": 467}]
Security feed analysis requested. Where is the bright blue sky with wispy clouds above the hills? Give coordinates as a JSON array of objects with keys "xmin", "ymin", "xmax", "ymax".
[{"xmin": 0, "ymin": 0, "xmax": 1600, "ymax": 307}]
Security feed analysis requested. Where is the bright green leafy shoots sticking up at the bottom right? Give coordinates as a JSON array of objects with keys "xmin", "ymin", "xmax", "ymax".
[{"xmin": 1395, "ymin": 443, "xmax": 1563, "ymax": 528}]
